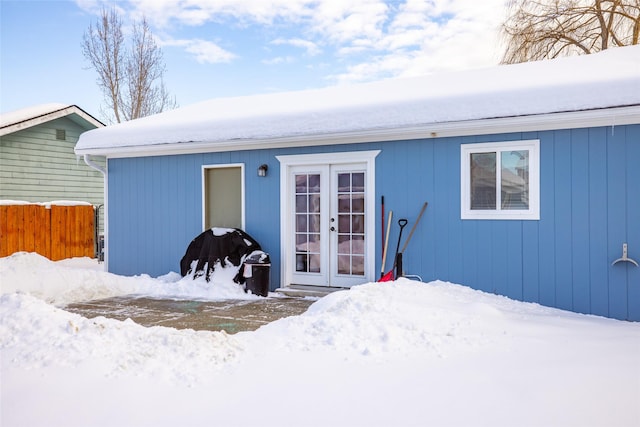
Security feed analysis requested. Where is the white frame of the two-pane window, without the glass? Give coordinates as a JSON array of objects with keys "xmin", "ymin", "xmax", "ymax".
[{"xmin": 460, "ymin": 139, "xmax": 540, "ymax": 220}]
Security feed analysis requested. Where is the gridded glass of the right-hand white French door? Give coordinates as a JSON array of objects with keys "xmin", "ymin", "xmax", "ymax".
[{"xmin": 336, "ymin": 172, "xmax": 365, "ymax": 276}]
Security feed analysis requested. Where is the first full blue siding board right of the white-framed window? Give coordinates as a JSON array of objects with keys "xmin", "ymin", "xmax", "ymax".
[{"xmin": 554, "ymin": 131, "xmax": 573, "ymax": 310}]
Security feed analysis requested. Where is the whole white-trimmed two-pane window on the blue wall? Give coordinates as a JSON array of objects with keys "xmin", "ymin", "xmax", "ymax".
[{"xmin": 460, "ymin": 139, "xmax": 540, "ymax": 220}]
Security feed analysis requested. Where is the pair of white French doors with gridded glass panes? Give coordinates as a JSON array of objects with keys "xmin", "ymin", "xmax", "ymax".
[{"xmin": 286, "ymin": 163, "xmax": 375, "ymax": 287}]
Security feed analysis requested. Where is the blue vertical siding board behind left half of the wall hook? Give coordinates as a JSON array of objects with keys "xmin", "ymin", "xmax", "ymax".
[{"xmin": 607, "ymin": 127, "xmax": 637, "ymax": 319}]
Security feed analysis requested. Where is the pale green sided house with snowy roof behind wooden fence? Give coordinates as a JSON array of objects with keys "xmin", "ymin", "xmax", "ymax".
[{"xmin": 0, "ymin": 104, "xmax": 105, "ymax": 228}]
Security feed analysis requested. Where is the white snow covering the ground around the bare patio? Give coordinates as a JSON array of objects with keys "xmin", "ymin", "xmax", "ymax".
[{"xmin": 0, "ymin": 253, "xmax": 640, "ymax": 426}]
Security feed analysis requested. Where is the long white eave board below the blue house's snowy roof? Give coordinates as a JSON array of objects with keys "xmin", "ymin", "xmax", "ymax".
[{"xmin": 76, "ymin": 104, "xmax": 640, "ymax": 158}]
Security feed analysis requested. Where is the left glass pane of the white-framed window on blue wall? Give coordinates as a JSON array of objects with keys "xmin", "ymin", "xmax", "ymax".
[{"xmin": 471, "ymin": 153, "xmax": 497, "ymax": 210}]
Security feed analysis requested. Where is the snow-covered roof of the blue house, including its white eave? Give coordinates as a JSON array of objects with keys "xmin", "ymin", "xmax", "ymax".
[{"xmin": 76, "ymin": 46, "xmax": 640, "ymax": 155}]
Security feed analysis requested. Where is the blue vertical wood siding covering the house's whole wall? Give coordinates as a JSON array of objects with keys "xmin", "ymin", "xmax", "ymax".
[{"xmin": 108, "ymin": 125, "xmax": 640, "ymax": 320}]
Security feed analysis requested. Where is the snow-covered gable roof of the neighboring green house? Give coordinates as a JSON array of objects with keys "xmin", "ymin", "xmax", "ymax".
[{"xmin": 0, "ymin": 104, "xmax": 104, "ymax": 136}]
